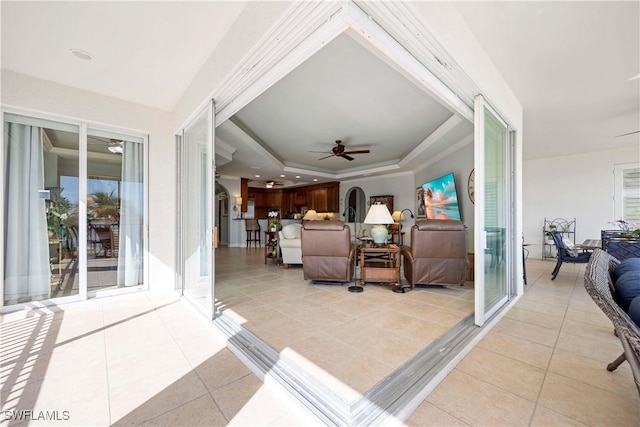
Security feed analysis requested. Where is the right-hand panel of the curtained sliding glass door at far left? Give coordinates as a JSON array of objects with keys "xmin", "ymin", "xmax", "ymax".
[{"xmin": 86, "ymin": 129, "xmax": 145, "ymax": 292}]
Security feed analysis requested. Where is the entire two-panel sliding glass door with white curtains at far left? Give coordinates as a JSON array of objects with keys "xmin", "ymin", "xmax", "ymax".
[{"xmin": 2, "ymin": 113, "xmax": 146, "ymax": 306}]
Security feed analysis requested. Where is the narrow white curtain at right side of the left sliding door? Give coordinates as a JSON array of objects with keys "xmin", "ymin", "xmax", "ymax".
[{"xmin": 118, "ymin": 141, "xmax": 144, "ymax": 286}]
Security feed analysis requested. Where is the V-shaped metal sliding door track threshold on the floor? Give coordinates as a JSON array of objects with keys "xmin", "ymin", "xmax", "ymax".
[{"xmin": 213, "ymin": 310, "xmax": 488, "ymax": 426}]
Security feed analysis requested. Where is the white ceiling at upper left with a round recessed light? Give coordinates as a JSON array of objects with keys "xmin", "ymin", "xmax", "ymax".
[{"xmin": 0, "ymin": 1, "xmax": 246, "ymax": 111}]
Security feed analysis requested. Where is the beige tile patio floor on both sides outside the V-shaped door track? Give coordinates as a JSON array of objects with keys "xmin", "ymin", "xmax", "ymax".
[{"xmin": 0, "ymin": 252, "xmax": 640, "ymax": 426}]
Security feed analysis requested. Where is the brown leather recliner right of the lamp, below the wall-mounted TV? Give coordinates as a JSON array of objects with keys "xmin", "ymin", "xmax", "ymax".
[{"xmin": 402, "ymin": 219, "xmax": 469, "ymax": 288}]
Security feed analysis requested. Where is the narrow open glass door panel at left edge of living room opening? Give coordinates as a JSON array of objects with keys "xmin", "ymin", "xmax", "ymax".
[{"xmin": 180, "ymin": 105, "xmax": 213, "ymax": 318}]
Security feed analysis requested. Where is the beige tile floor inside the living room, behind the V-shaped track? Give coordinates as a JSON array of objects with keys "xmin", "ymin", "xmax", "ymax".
[{"xmin": 216, "ymin": 248, "xmax": 474, "ymax": 402}]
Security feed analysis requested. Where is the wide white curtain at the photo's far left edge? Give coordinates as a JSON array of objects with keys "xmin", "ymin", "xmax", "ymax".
[{"xmin": 4, "ymin": 122, "xmax": 51, "ymax": 305}]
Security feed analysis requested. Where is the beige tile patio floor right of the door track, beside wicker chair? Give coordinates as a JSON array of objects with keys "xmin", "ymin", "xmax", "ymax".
[{"xmin": 406, "ymin": 260, "xmax": 640, "ymax": 426}]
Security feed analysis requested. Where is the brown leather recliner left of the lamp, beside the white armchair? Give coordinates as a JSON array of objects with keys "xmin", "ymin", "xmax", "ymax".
[{"xmin": 300, "ymin": 220, "xmax": 355, "ymax": 282}]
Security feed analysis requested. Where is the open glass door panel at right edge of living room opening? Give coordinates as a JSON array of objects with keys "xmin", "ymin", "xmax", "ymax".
[{"xmin": 474, "ymin": 96, "xmax": 511, "ymax": 326}]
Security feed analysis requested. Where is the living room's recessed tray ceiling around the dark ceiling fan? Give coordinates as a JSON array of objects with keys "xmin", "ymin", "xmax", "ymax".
[{"xmin": 216, "ymin": 33, "xmax": 472, "ymax": 185}]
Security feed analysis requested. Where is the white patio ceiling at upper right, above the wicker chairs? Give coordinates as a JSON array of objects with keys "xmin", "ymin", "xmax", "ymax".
[{"xmin": 455, "ymin": 1, "xmax": 640, "ymax": 160}]
